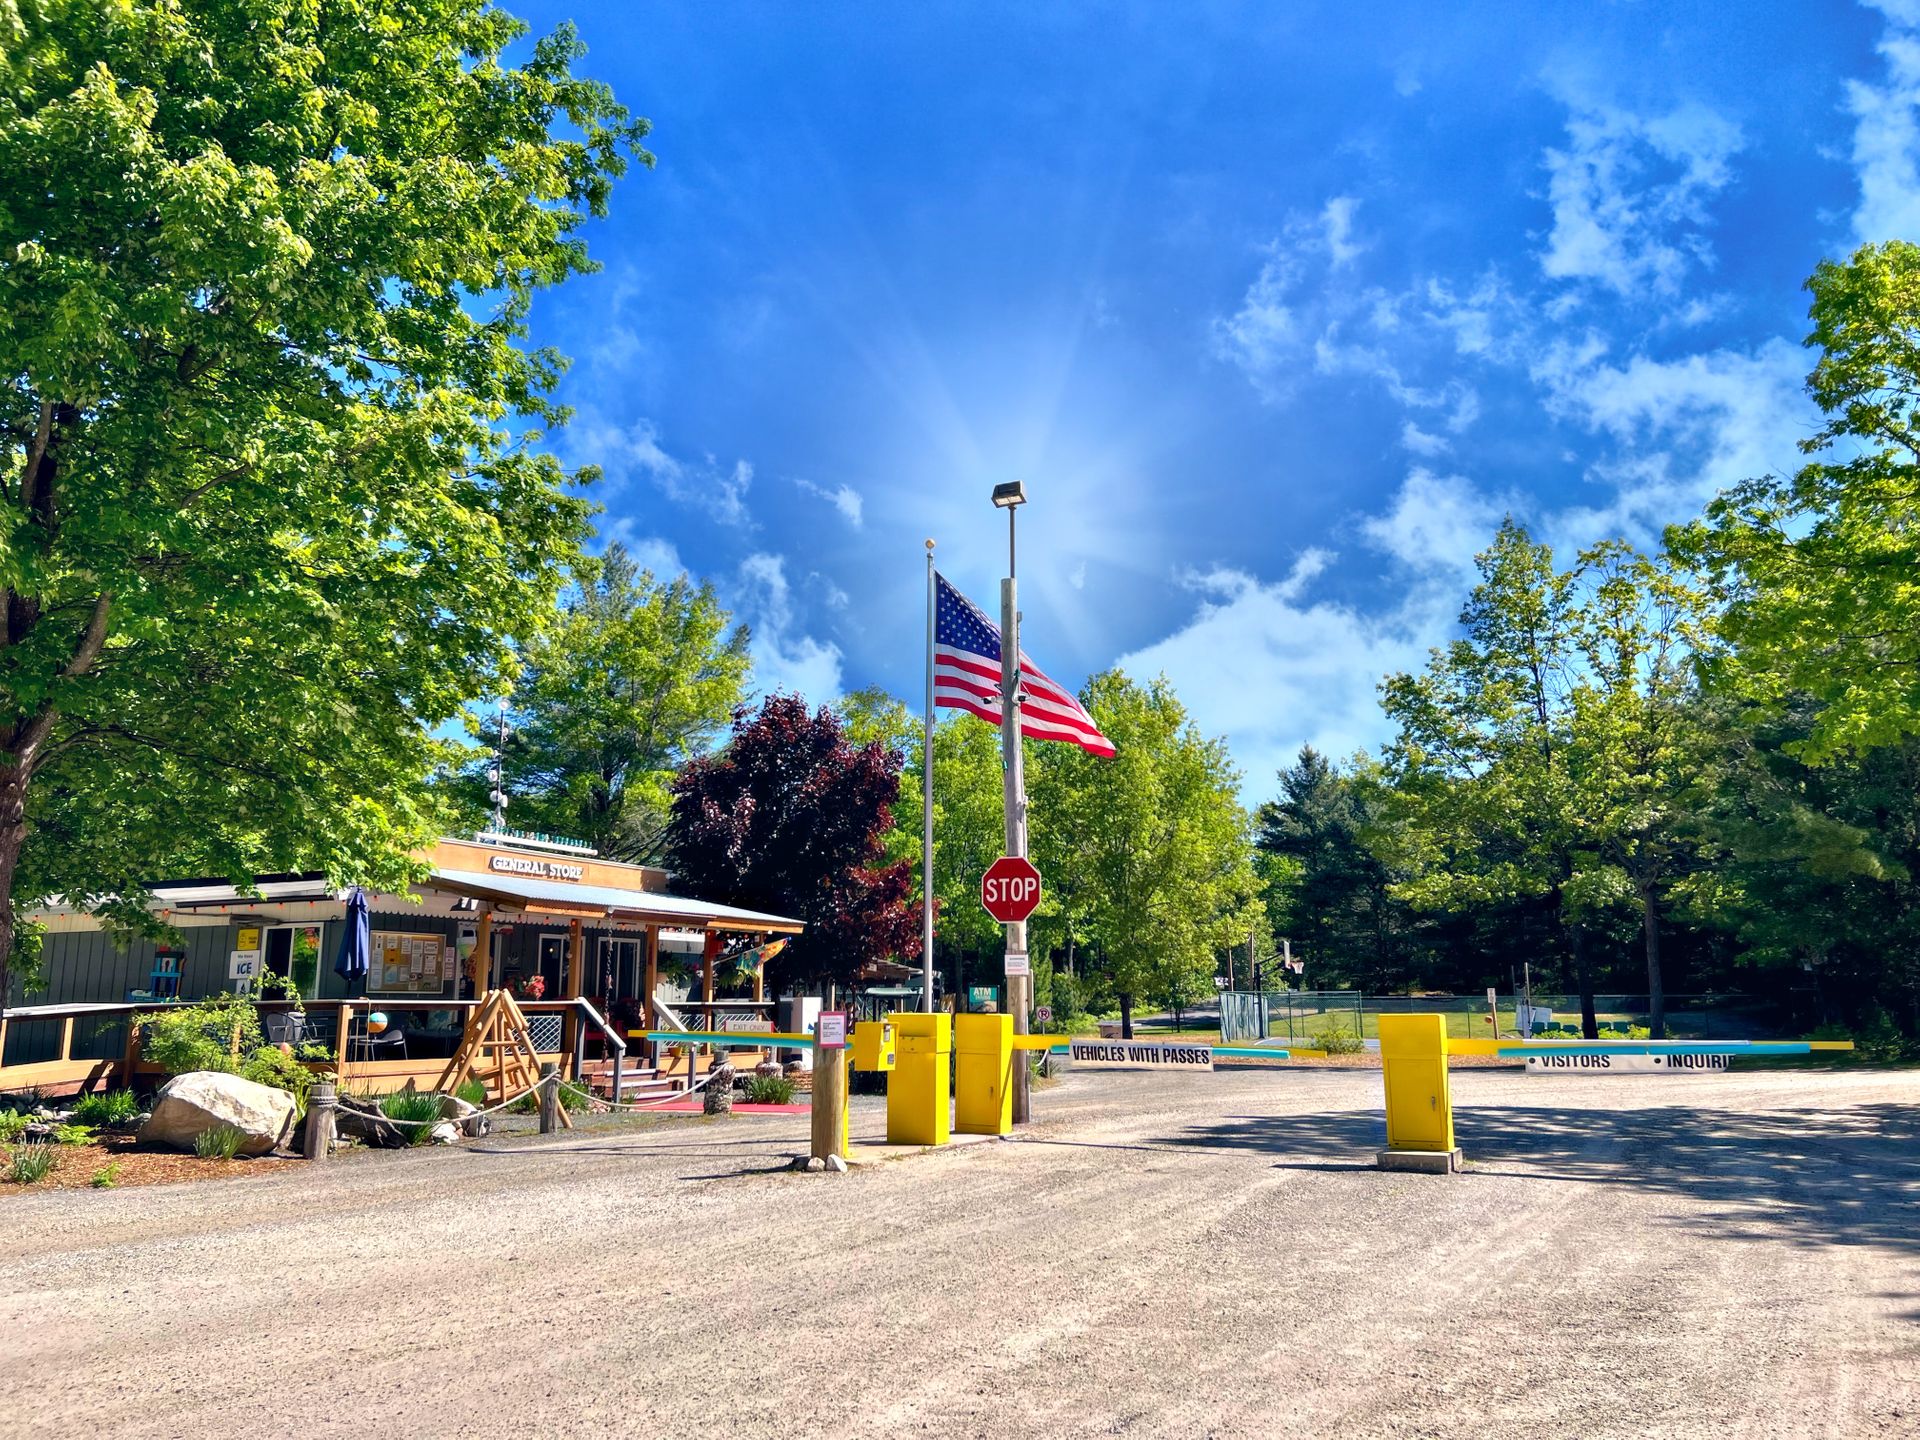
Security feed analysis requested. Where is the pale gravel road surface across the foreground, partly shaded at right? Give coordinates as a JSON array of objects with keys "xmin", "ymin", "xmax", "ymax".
[{"xmin": 0, "ymin": 1069, "xmax": 1920, "ymax": 1440}]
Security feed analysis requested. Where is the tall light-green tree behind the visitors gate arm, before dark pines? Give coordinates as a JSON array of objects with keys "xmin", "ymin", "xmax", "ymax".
[{"xmin": 1382, "ymin": 520, "xmax": 1713, "ymax": 1035}]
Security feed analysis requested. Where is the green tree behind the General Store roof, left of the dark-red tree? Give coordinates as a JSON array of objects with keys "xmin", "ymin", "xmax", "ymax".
[{"xmin": 467, "ymin": 543, "xmax": 749, "ymax": 860}]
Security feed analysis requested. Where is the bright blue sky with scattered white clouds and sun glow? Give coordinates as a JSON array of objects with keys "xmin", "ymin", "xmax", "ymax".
[{"xmin": 513, "ymin": 0, "xmax": 1920, "ymax": 799}]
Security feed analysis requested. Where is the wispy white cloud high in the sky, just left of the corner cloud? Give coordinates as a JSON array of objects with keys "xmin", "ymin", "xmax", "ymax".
[{"xmin": 1540, "ymin": 104, "xmax": 1741, "ymax": 296}]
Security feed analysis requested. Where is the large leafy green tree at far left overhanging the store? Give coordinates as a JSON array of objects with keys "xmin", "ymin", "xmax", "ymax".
[{"xmin": 0, "ymin": 0, "xmax": 647, "ymax": 1002}]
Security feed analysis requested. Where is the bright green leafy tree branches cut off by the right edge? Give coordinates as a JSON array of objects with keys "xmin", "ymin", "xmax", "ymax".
[{"xmin": 1672, "ymin": 240, "xmax": 1920, "ymax": 764}]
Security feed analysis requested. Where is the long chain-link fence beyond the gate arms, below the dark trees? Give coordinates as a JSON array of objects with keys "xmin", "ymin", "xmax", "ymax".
[{"xmin": 1219, "ymin": 991, "xmax": 1807, "ymax": 1044}]
